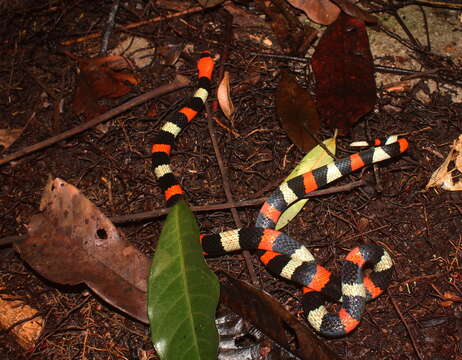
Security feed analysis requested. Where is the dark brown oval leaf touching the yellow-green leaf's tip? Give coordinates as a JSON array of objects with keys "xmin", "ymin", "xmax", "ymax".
[{"xmin": 276, "ymin": 70, "xmax": 320, "ymax": 152}]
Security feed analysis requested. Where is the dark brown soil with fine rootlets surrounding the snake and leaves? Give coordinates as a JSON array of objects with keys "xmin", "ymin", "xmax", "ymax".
[{"xmin": 0, "ymin": 0, "xmax": 462, "ymax": 360}]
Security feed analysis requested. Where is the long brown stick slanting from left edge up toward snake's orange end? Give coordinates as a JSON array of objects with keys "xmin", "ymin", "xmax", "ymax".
[{"xmin": 0, "ymin": 75, "xmax": 190, "ymax": 166}]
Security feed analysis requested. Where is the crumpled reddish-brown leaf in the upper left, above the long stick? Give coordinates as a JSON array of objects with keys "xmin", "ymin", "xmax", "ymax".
[{"xmin": 72, "ymin": 56, "xmax": 140, "ymax": 118}]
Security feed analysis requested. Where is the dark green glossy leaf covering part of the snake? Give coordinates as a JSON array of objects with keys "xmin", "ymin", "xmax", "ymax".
[{"xmin": 148, "ymin": 201, "xmax": 219, "ymax": 360}]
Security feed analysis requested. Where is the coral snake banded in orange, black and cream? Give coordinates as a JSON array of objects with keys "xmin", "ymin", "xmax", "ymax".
[{"xmin": 152, "ymin": 52, "xmax": 408, "ymax": 337}]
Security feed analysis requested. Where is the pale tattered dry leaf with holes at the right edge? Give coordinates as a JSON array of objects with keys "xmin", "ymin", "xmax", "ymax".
[{"xmin": 426, "ymin": 134, "xmax": 462, "ymax": 191}]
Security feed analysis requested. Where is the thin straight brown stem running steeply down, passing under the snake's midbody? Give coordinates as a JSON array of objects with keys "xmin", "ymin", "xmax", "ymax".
[{"xmin": 205, "ymin": 103, "xmax": 258, "ymax": 285}]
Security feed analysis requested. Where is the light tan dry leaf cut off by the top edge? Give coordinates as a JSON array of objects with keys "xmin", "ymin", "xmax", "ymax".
[{"xmin": 287, "ymin": 0, "xmax": 340, "ymax": 25}]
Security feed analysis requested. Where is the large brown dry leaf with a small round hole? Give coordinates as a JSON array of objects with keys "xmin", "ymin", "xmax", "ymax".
[{"xmin": 15, "ymin": 178, "xmax": 150, "ymax": 322}]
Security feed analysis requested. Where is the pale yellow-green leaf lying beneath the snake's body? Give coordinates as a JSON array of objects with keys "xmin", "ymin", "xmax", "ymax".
[{"xmin": 276, "ymin": 135, "xmax": 336, "ymax": 230}]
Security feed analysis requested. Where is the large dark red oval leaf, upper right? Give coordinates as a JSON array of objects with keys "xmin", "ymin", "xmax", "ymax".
[{"xmin": 311, "ymin": 13, "xmax": 377, "ymax": 135}]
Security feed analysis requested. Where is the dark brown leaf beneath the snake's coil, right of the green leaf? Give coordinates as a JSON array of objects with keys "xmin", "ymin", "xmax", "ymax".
[{"xmin": 220, "ymin": 273, "xmax": 339, "ymax": 360}]
